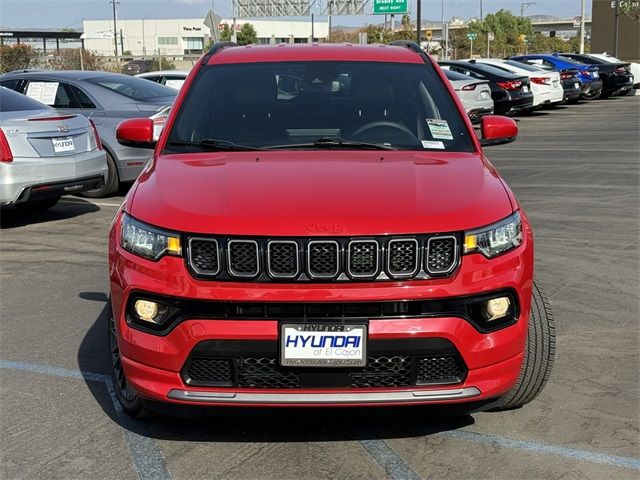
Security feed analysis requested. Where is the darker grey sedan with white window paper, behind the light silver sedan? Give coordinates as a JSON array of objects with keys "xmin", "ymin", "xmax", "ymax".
[{"xmin": 0, "ymin": 70, "xmax": 178, "ymax": 197}]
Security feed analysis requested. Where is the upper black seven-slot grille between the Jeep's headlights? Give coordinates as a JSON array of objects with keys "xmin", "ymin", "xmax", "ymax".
[{"xmin": 187, "ymin": 234, "xmax": 460, "ymax": 282}]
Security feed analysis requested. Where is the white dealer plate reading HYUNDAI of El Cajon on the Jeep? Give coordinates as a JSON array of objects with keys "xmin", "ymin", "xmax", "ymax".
[{"xmin": 280, "ymin": 324, "xmax": 367, "ymax": 367}]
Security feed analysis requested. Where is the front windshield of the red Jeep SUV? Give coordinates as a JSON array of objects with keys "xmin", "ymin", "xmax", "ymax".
[{"xmin": 165, "ymin": 62, "xmax": 473, "ymax": 153}]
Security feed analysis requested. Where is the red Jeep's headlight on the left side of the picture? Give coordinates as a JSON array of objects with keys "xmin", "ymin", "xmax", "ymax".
[{"xmin": 120, "ymin": 213, "xmax": 182, "ymax": 260}]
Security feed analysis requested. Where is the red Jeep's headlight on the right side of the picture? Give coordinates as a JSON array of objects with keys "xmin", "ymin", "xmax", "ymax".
[{"xmin": 464, "ymin": 212, "xmax": 522, "ymax": 258}]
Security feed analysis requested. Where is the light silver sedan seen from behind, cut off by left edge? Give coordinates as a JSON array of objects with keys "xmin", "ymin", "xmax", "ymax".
[{"xmin": 0, "ymin": 87, "xmax": 107, "ymax": 209}]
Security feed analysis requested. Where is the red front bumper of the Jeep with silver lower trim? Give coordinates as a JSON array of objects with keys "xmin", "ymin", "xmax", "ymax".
[{"xmin": 109, "ymin": 216, "xmax": 533, "ymax": 406}]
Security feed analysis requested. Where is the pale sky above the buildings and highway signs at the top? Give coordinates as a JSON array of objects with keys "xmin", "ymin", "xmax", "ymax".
[{"xmin": 0, "ymin": 0, "xmax": 591, "ymax": 30}]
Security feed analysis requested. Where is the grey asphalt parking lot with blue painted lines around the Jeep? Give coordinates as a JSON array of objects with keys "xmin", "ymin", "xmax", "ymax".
[{"xmin": 0, "ymin": 97, "xmax": 640, "ymax": 480}]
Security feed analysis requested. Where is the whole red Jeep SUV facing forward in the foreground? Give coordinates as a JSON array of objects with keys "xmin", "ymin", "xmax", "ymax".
[{"xmin": 109, "ymin": 42, "xmax": 555, "ymax": 416}]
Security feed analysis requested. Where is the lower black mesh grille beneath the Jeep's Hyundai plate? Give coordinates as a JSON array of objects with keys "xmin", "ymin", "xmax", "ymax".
[{"xmin": 181, "ymin": 338, "xmax": 467, "ymax": 389}]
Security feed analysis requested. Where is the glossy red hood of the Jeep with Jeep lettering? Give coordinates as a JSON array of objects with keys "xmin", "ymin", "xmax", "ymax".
[{"xmin": 126, "ymin": 150, "xmax": 513, "ymax": 236}]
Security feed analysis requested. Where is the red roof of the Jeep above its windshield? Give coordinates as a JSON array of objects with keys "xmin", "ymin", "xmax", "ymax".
[{"xmin": 209, "ymin": 43, "xmax": 424, "ymax": 65}]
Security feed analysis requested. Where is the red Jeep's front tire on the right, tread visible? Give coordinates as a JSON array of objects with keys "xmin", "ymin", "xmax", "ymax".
[{"xmin": 490, "ymin": 282, "xmax": 556, "ymax": 411}]
